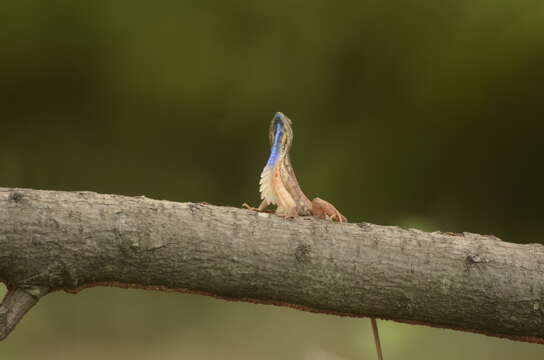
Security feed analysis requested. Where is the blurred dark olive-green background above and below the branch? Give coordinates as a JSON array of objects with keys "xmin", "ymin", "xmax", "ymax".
[{"xmin": 0, "ymin": 0, "xmax": 544, "ymax": 360}]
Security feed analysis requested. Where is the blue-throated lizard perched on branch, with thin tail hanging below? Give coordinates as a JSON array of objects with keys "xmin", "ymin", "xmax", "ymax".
[{"xmin": 242, "ymin": 112, "xmax": 383, "ymax": 360}]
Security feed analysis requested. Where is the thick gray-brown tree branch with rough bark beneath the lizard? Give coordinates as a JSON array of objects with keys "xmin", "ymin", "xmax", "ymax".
[{"xmin": 0, "ymin": 188, "xmax": 544, "ymax": 343}]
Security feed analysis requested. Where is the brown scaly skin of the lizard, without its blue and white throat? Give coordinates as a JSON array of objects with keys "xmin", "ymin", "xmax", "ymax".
[{"xmin": 243, "ymin": 113, "xmax": 348, "ymax": 222}]
